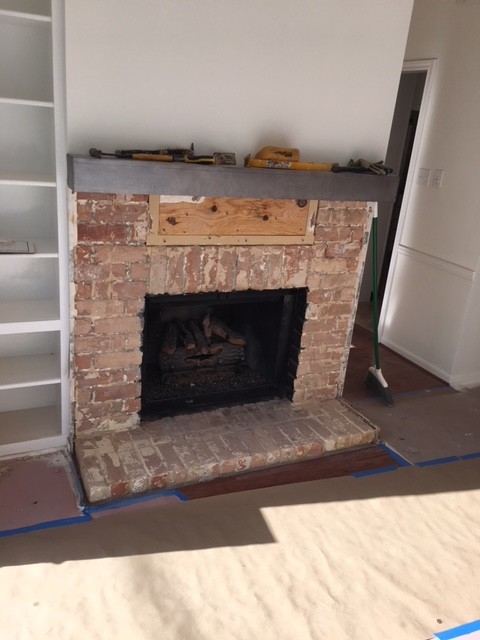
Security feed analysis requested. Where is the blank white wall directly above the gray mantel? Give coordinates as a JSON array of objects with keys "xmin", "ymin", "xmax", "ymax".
[{"xmin": 66, "ymin": 0, "xmax": 413, "ymax": 163}]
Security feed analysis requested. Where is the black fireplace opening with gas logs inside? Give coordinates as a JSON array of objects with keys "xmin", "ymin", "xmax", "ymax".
[{"xmin": 141, "ymin": 289, "xmax": 307, "ymax": 419}]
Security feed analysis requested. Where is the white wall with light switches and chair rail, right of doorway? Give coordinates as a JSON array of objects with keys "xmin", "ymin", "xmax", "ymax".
[{"xmin": 380, "ymin": 0, "xmax": 480, "ymax": 386}]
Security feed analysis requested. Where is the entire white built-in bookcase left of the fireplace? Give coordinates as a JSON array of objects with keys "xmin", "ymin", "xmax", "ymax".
[{"xmin": 0, "ymin": 0, "xmax": 70, "ymax": 457}]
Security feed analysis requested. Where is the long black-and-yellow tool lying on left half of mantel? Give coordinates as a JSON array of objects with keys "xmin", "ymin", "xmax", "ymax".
[{"xmin": 89, "ymin": 143, "xmax": 236, "ymax": 165}]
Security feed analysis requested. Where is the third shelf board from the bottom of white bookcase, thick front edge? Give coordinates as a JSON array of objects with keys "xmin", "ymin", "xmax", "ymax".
[{"xmin": 0, "ymin": 300, "xmax": 60, "ymax": 335}]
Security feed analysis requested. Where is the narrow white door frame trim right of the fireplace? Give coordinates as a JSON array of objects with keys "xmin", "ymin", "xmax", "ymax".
[{"xmin": 378, "ymin": 58, "xmax": 437, "ymax": 341}]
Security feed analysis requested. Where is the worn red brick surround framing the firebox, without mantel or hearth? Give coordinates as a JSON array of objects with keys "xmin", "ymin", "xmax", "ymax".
[{"xmin": 73, "ymin": 193, "xmax": 370, "ymax": 435}]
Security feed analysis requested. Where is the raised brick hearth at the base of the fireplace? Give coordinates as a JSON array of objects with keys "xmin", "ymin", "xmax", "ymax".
[{"xmin": 76, "ymin": 400, "xmax": 377, "ymax": 502}]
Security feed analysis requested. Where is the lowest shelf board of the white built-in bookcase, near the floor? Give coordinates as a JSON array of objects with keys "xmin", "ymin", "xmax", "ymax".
[{"xmin": 0, "ymin": 405, "xmax": 63, "ymax": 456}]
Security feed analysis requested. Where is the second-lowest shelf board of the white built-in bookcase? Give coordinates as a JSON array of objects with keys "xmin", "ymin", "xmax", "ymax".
[{"xmin": 0, "ymin": 354, "xmax": 60, "ymax": 389}]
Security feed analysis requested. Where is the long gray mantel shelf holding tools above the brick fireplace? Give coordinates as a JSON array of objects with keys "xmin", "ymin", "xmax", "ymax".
[{"xmin": 67, "ymin": 155, "xmax": 398, "ymax": 202}]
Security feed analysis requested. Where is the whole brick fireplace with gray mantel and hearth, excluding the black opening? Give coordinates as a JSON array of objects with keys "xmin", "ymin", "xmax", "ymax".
[{"xmin": 69, "ymin": 157, "xmax": 395, "ymax": 502}]
